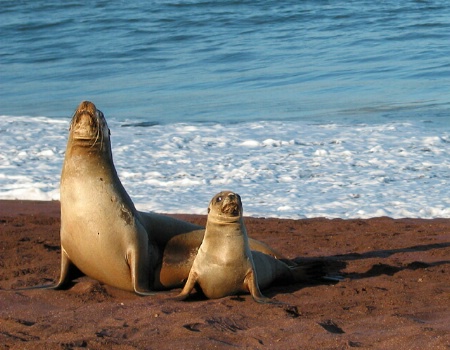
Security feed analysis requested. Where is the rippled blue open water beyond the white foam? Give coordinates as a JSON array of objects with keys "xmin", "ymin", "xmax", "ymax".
[{"xmin": 0, "ymin": 0, "xmax": 450, "ymax": 126}]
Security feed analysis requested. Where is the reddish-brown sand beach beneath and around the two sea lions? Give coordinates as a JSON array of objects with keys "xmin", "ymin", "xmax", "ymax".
[{"xmin": 0, "ymin": 201, "xmax": 450, "ymax": 349}]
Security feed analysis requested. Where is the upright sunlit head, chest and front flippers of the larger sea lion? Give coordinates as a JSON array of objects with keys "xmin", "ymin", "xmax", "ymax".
[{"xmin": 55, "ymin": 101, "xmax": 158, "ymax": 294}]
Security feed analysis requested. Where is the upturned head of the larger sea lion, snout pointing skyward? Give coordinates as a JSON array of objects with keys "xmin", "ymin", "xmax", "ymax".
[{"xmin": 70, "ymin": 101, "xmax": 110, "ymax": 149}]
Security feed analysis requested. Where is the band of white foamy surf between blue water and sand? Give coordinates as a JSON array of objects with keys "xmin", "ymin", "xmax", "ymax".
[{"xmin": 0, "ymin": 116, "xmax": 450, "ymax": 218}]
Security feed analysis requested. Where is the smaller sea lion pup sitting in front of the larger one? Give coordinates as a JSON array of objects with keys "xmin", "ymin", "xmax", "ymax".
[{"xmin": 175, "ymin": 191, "xmax": 314, "ymax": 303}]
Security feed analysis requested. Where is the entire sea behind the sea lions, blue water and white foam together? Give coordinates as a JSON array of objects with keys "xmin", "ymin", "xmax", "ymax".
[{"xmin": 0, "ymin": 0, "xmax": 450, "ymax": 218}]
